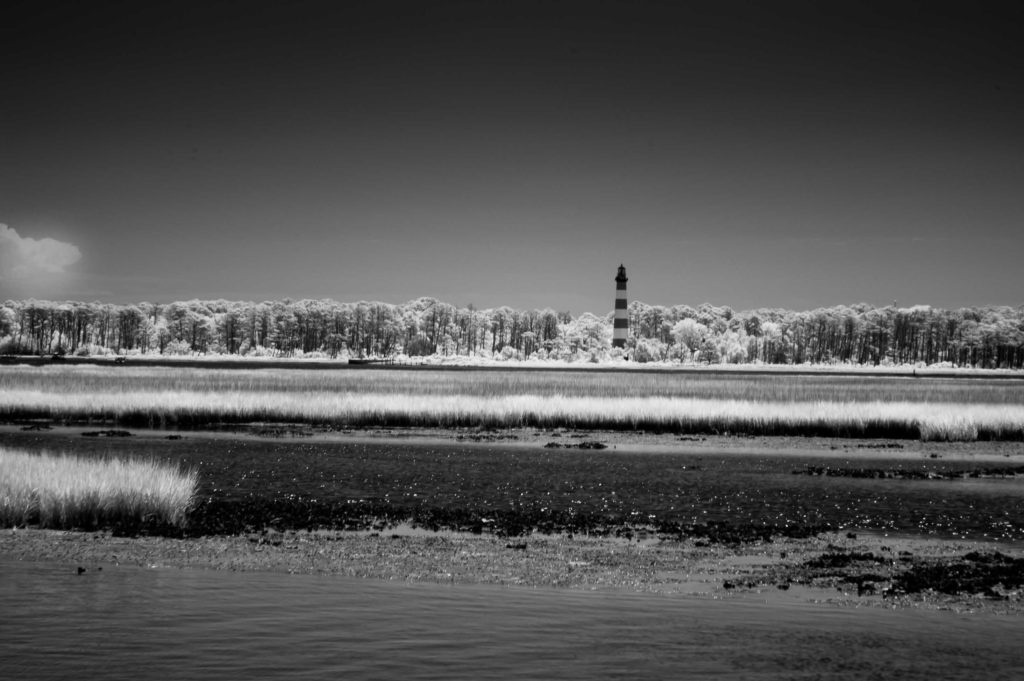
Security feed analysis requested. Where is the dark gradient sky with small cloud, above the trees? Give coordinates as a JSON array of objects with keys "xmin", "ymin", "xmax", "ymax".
[{"xmin": 0, "ymin": 0, "xmax": 1024, "ymax": 313}]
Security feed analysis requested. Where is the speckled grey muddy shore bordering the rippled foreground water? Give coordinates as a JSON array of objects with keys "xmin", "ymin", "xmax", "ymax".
[{"xmin": 0, "ymin": 527, "xmax": 1024, "ymax": 616}]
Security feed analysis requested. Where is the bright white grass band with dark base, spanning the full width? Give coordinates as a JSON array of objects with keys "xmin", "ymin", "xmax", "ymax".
[{"xmin": 0, "ymin": 390, "xmax": 1024, "ymax": 440}]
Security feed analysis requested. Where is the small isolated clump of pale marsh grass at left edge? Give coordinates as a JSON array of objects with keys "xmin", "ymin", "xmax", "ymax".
[{"xmin": 0, "ymin": 448, "xmax": 199, "ymax": 529}]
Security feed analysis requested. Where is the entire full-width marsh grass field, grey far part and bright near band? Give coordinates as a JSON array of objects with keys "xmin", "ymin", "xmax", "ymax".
[{"xmin": 0, "ymin": 367, "xmax": 1024, "ymax": 440}]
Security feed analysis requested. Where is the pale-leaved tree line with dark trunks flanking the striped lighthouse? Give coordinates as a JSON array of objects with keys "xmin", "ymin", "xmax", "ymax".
[{"xmin": 0, "ymin": 298, "xmax": 1024, "ymax": 369}]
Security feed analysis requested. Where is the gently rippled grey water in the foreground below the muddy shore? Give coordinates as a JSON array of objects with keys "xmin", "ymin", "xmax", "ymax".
[{"xmin": 0, "ymin": 559, "xmax": 1024, "ymax": 681}]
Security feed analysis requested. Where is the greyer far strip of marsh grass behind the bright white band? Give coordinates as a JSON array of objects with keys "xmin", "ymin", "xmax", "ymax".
[{"xmin": 0, "ymin": 365, "xmax": 1024, "ymax": 405}]
